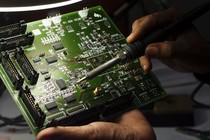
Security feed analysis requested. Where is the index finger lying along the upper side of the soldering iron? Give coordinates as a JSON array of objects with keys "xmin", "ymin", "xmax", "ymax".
[{"xmin": 127, "ymin": 7, "xmax": 181, "ymax": 43}]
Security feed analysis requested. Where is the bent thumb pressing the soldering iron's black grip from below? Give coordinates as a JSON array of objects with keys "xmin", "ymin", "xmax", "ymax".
[{"xmin": 145, "ymin": 41, "xmax": 176, "ymax": 59}]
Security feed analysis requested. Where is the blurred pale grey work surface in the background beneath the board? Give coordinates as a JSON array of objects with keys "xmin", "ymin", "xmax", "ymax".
[{"xmin": 0, "ymin": 61, "xmax": 210, "ymax": 140}]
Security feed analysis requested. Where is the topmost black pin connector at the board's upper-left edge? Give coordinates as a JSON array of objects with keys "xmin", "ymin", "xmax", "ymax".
[{"xmin": 0, "ymin": 20, "xmax": 27, "ymax": 38}]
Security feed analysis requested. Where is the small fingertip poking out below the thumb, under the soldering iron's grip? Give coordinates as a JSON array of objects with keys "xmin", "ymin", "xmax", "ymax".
[{"xmin": 139, "ymin": 55, "xmax": 152, "ymax": 73}]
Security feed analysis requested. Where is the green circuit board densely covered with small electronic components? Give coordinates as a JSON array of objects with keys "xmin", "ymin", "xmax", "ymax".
[{"xmin": 0, "ymin": 6, "xmax": 165, "ymax": 135}]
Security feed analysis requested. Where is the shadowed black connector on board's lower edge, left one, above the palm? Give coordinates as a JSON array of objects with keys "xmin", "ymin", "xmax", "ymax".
[{"xmin": 46, "ymin": 107, "xmax": 100, "ymax": 127}]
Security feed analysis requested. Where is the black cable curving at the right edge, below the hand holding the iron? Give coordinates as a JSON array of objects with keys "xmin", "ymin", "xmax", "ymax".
[{"xmin": 191, "ymin": 82, "xmax": 210, "ymax": 108}]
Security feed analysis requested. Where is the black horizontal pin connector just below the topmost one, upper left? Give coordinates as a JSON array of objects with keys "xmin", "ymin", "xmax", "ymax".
[{"xmin": 0, "ymin": 32, "xmax": 34, "ymax": 51}]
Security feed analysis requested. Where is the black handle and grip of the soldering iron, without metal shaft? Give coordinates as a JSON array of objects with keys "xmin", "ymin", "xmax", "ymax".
[{"xmin": 124, "ymin": 2, "xmax": 210, "ymax": 59}]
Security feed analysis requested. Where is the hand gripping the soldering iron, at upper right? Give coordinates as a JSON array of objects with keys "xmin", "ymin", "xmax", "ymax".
[{"xmin": 127, "ymin": 8, "xmax": 210, "ymax": 74}]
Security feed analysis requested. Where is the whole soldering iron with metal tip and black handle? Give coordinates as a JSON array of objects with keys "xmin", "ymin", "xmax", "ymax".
[{"xmin": 78, "ymin": 2, "xmax": 210, "ymax": 83}]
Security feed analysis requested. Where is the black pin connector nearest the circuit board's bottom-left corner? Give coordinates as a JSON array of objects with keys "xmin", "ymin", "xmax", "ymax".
[{"xmin": 19, "ymin": 86, "xmax": 46, "ymax": 127}]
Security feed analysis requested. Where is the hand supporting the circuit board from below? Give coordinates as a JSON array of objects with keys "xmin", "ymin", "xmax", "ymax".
[{"xmin": 36, "ymin": 109, "xmax": 156, "ymax": 140}]
